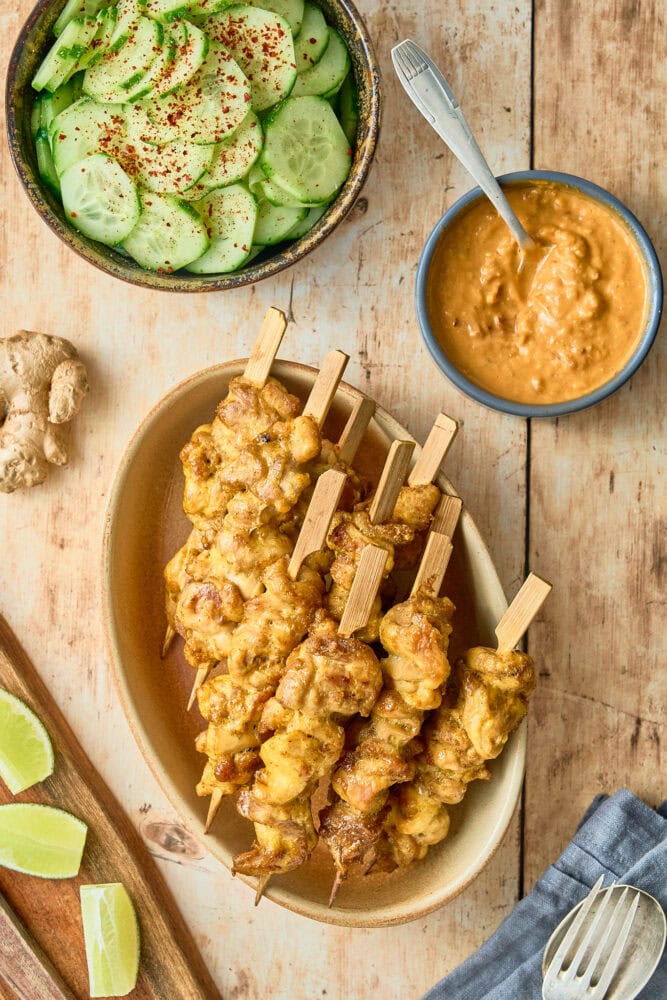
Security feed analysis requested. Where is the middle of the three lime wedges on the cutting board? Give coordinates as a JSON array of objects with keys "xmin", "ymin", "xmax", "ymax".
[{"xmin": 0, "ymin": 802, "xmax": 88, "ymax": 878}]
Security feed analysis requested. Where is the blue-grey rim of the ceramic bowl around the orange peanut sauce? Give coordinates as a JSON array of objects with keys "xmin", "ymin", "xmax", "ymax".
[{"xmin": 415, "ymin": 170, "xmax": 663, "ymax": 417}]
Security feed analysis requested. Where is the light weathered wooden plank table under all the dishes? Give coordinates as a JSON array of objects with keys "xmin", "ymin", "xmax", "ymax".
[{"xmin": 0, "ymin": 0, "xmax": 667, "ymax": 1000}]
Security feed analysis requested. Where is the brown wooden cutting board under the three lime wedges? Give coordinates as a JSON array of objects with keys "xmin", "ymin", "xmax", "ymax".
[{"xmin": 0, "ymin": 615, "xmax": 220, "ymax": 1000}]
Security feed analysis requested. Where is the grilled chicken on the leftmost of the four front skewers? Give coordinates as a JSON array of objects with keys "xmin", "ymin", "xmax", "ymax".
[{"xmin": 196, "ymin": 558, "xmax": 324, "ymax": 795}]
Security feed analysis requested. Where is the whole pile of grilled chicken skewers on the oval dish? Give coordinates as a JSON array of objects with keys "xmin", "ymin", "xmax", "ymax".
[{"xmin": 164, "ymin": 309, "xmax": 550, "ymax": 904}]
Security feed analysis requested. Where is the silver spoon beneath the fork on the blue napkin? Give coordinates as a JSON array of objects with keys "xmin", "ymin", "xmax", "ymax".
[{"xmin": 542, "ymin": 885, "xmax": 667, "ymax": 1000}]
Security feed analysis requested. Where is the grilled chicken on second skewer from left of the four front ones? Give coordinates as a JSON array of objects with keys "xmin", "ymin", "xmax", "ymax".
[{"xmin": 234, "ymin": 611, "xmax": 382, "ymax": 876}]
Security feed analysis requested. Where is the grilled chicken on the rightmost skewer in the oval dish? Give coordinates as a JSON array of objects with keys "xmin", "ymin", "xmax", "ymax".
[{"xmin": 377, "ymin": 646, "xmax": 535, "ymax": 869}]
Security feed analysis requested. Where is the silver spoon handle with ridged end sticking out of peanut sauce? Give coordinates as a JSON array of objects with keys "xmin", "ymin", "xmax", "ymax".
[{"xmin": 391, "ymin": 38, "xmax": 535, "ymax": 250}]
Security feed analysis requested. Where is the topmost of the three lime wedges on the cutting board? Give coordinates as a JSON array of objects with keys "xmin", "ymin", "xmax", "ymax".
[{"xmin": 0, "ymin": 688, "xmax": 53, "ymax": 795}]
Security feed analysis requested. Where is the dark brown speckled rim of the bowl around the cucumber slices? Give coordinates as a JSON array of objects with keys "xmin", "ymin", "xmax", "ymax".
[{"xmin": 5, "ymin": 0, "xmax": 381, "ymax": 292}]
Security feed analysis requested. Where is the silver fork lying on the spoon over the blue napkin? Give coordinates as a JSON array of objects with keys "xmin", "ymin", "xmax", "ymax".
[{"xmin": 542, "ymin": 876, "xmax": 641, "ymax": 1000}]
